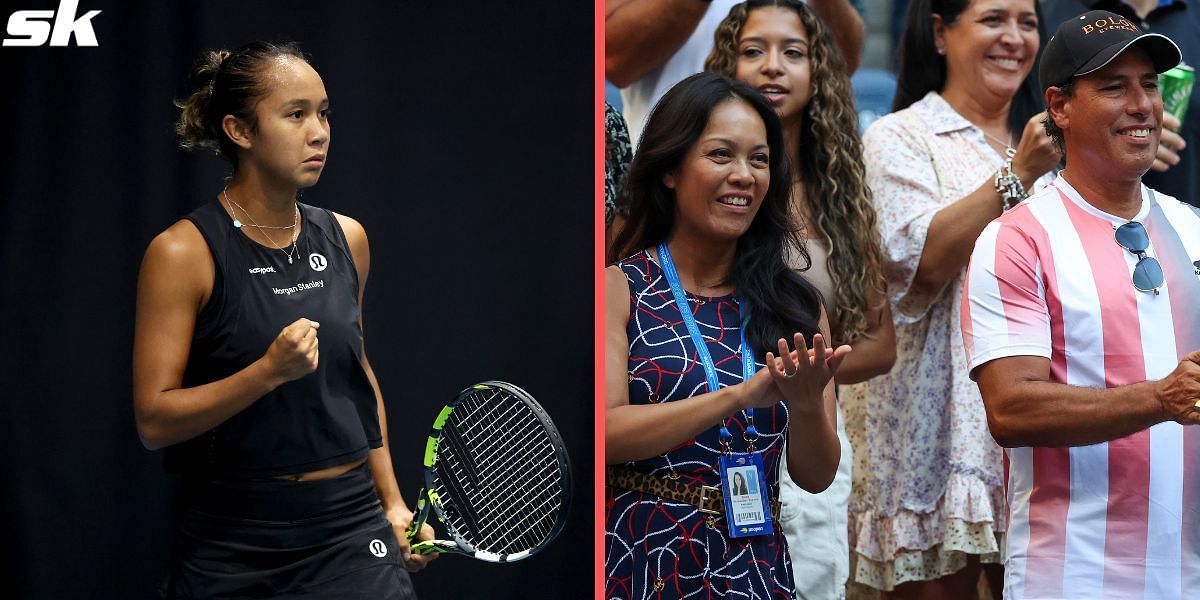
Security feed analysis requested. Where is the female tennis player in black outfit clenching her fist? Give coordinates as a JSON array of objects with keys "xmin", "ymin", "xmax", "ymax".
[{"xmin": 133, "ymin": 42, "xmax": 433, "ymax": 599}]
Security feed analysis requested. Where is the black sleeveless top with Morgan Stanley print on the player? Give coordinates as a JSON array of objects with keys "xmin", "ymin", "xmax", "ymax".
[{"xmin": 166, "ymin": 202, "xmax": 383, "ymax": 478}]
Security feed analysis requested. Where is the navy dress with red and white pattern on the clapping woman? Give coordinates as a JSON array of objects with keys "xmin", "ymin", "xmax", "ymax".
[{"xmin": 605, "ymin": 251, "xmax": 793, "ymax": 600}]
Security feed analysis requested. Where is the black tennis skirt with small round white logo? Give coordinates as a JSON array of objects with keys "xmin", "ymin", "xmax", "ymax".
[{"xmin": 164, "ymin": 463, "xmax": 416, "ymax": 600}]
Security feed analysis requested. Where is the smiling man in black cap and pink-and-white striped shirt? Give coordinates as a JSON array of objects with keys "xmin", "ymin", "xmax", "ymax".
[{"xmin": 962, "ymin": 11, "xmax": 1200, "ymax": 600}]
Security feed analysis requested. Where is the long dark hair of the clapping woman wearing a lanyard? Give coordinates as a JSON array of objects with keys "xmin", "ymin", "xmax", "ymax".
[{"xmin": 613, "ymin": 72, "xmax": 821, "ymax": 356}]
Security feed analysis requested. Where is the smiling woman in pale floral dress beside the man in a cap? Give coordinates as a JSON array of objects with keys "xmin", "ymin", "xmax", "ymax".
[{"xmin": 841, "ymin": 0, "xmax": 1060, "ymax": 599}]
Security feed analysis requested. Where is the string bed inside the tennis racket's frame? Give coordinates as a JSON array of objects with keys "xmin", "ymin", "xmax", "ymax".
[{"xmin": 437, "ymin": 394, "xmax": 564, "ymax": 553}]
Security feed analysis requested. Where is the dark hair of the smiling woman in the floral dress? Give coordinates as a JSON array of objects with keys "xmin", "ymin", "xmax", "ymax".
[{"xmin": 892, "ymin": 0, "xmax": 1045, "ymax": 137}]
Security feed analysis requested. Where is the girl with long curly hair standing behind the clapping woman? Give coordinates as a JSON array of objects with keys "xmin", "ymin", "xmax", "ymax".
[{"xmin": 704, "ymin": 0, "xmax": 895, "ymax": 599}]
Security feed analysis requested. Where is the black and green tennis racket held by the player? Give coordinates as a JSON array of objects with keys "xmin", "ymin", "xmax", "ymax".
[{"xmin": 407, "ymin": 382, "xmax": 571, "ymax": 563}]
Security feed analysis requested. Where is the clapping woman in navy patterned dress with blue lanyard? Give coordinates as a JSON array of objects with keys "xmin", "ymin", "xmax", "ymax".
[{"xmin": 605, "ymin": 73, "xmax": 850, "ymax": 599}]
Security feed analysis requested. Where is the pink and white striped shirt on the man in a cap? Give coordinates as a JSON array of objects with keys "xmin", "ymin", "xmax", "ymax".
[{"xmin": 962, "ymin": 178, "xmax": 1200, "ymax": 600}]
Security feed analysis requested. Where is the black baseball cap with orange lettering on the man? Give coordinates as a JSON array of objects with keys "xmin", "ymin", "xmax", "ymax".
[{"xmin": 1038, "ymin": 11, "xmax": 1183, "ymax": 90}]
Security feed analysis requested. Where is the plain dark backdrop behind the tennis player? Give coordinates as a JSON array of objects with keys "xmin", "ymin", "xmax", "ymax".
[{"xmin": 0, "ymin": 0, "xmax": 594, "ymax": 599}]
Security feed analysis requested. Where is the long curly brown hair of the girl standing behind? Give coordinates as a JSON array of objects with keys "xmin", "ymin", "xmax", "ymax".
[{"xmin": 704, "ymin": 0, "xmax": 887, "ymax": 344}]
